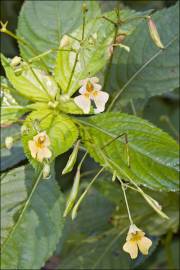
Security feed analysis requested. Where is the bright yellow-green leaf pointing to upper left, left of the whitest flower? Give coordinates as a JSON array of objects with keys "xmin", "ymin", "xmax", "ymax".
[{"xmin": 1, "ymin": 55, "xmax": 59, "ymax": 102}]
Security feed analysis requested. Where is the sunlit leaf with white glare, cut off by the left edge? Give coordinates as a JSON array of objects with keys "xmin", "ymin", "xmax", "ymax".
[{"xmin": 1, "ymin": 77, "xmax": 28, "ymax": 125}]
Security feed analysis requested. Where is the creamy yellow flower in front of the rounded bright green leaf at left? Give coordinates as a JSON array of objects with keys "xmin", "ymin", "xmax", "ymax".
[{"xmin": 28, "ymin": 131, "xmax": 52, "ymax": 162}]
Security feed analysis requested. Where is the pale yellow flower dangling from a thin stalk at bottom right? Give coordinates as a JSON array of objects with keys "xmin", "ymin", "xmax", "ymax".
[{"xmin": 123, "ymin": 224, "xmax": 152, "ymax": 259}]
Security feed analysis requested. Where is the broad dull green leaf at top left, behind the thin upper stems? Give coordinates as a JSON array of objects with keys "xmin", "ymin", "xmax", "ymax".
[{"xmin": 17, "ymin": 1, "xmax": 100, "ymax": 70}]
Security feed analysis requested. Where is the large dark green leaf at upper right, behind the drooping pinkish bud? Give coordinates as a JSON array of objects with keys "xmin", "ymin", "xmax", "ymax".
[{"xmin": 108, "ymin": 3, "xmax": 179, "ymax": 110}]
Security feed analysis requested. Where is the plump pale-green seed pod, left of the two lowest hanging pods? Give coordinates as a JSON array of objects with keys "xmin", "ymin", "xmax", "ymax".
[{"xmin": 63, "ymin": 167, "xmax": 80, "ymax": 217}]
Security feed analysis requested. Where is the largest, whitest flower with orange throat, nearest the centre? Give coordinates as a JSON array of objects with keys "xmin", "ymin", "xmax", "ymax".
[{"xmin": 74, "ymin": 77, "xmax": 109, "ymax": 113}]
